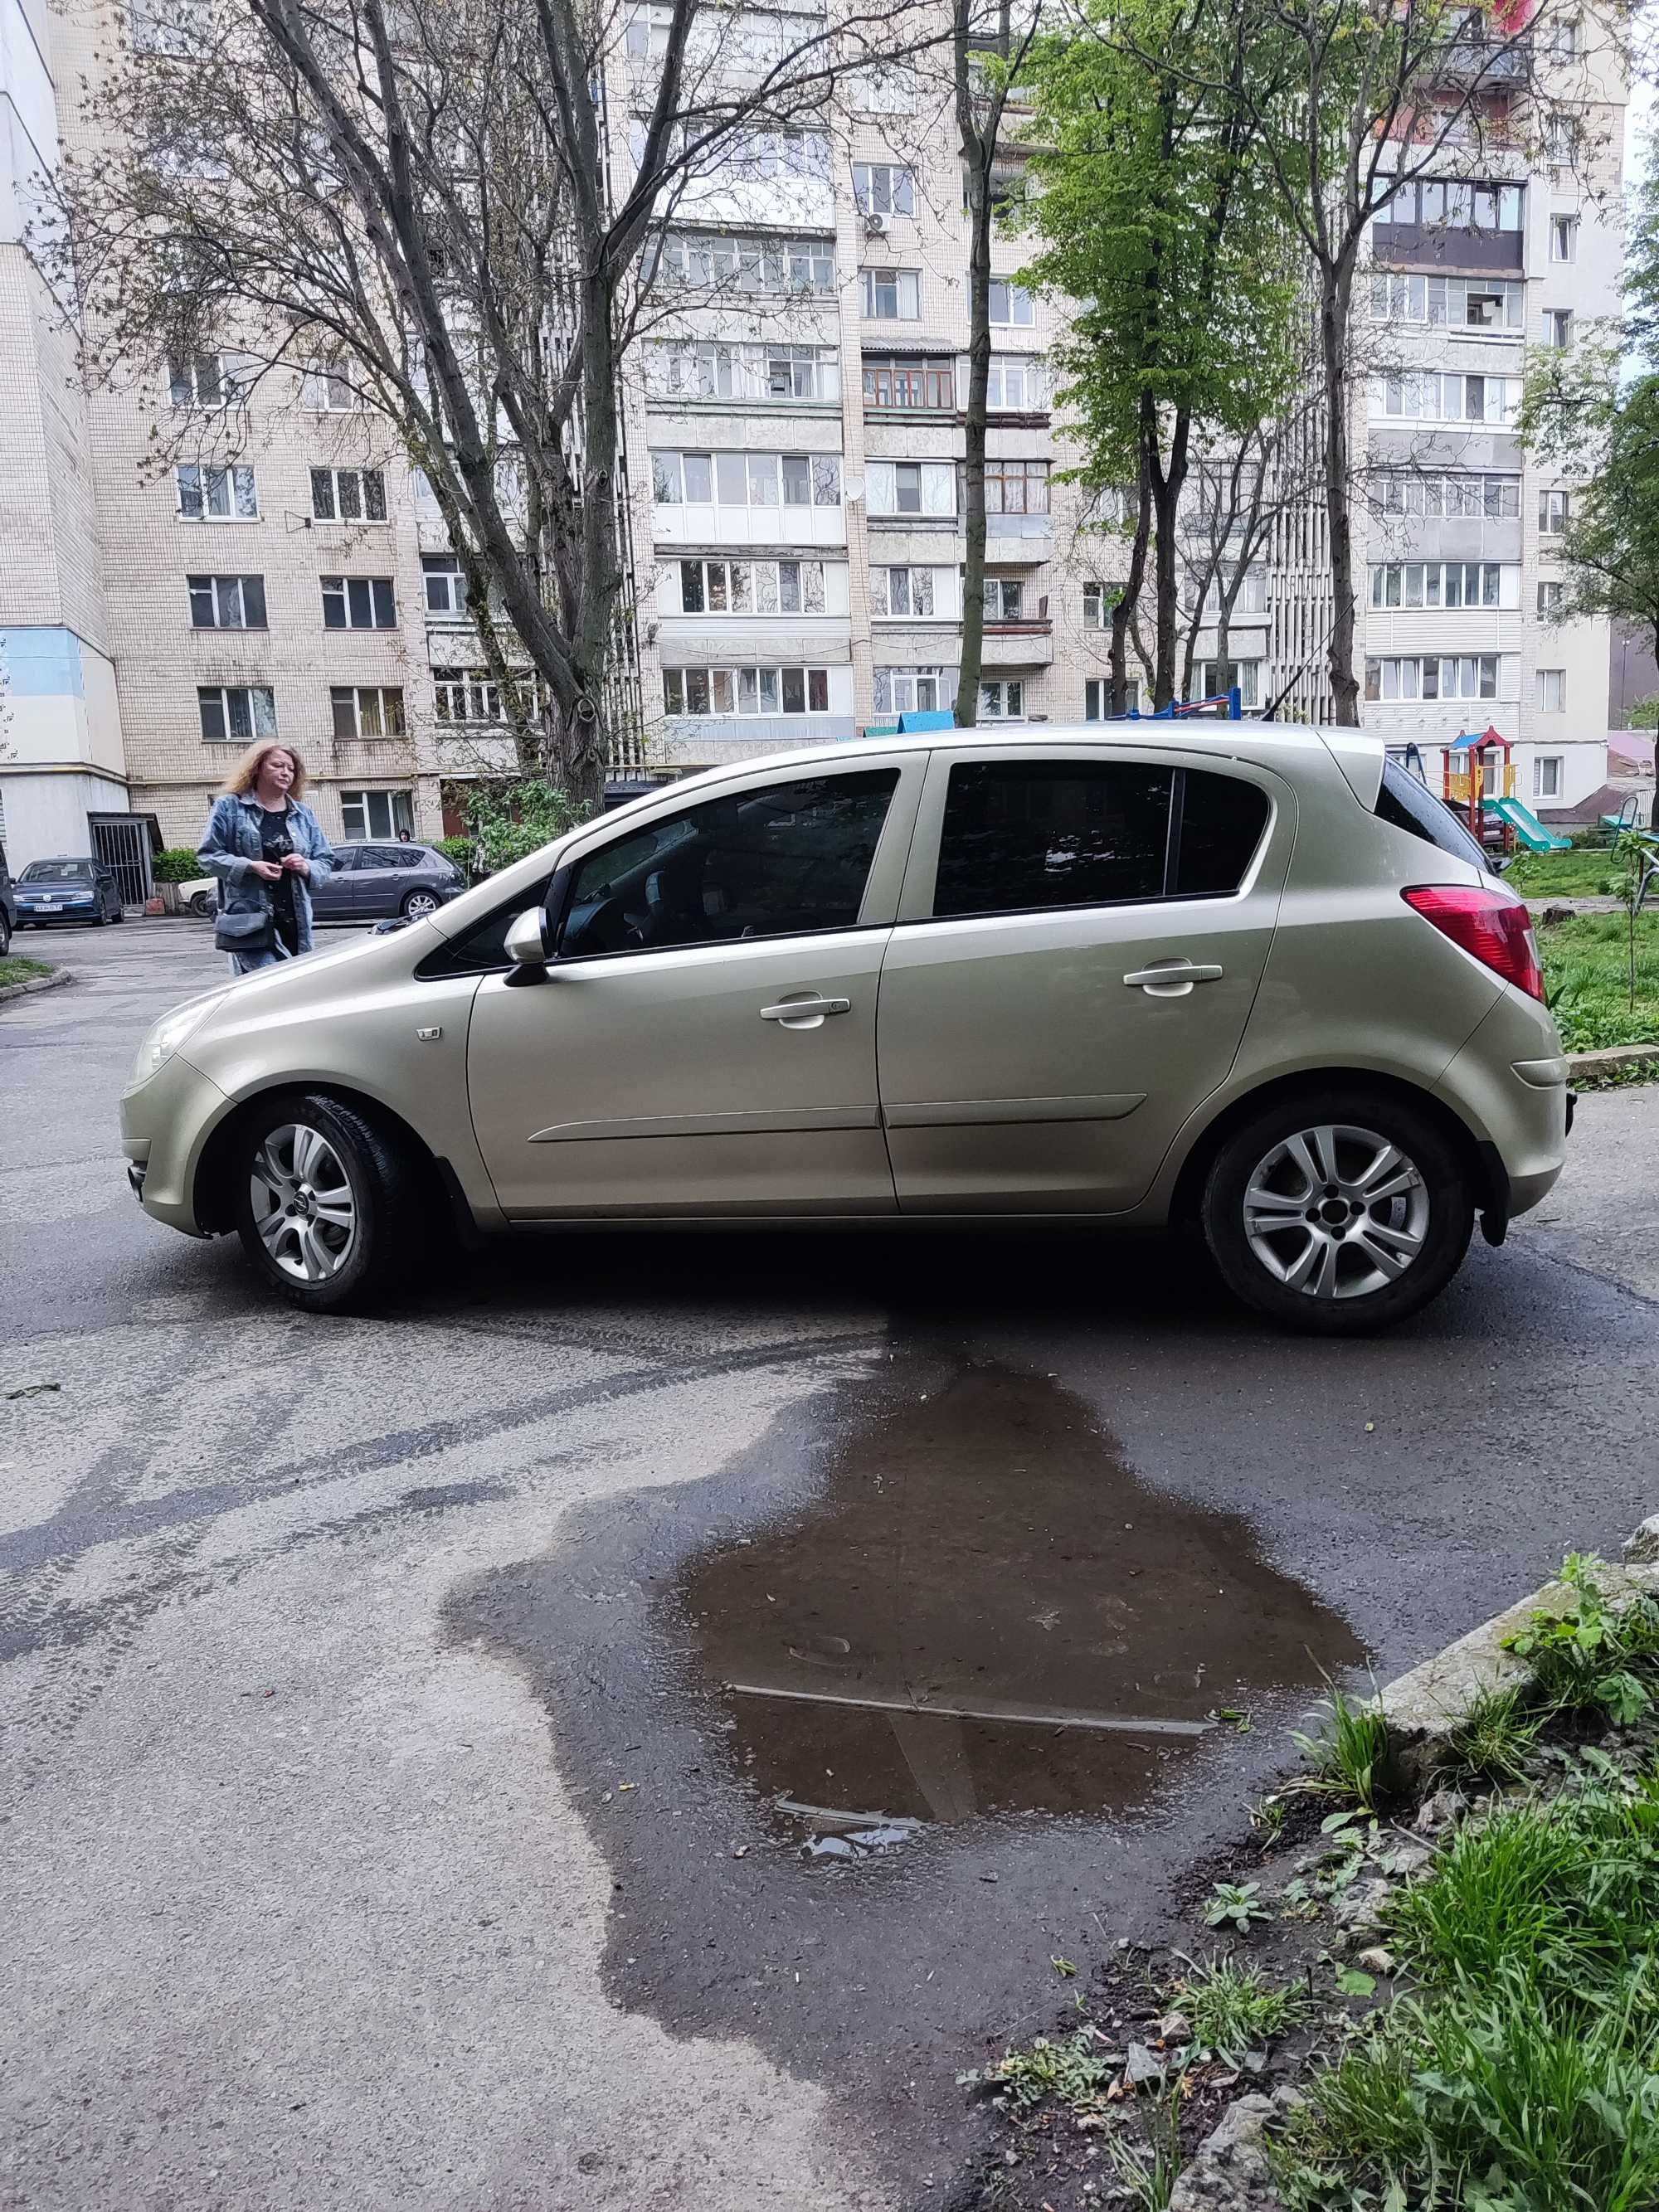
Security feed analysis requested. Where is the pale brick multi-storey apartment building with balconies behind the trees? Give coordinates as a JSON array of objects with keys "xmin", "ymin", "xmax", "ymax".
[{"xmin": 0, "ymin": 0, "xmax": 1623, "ymax": 858}]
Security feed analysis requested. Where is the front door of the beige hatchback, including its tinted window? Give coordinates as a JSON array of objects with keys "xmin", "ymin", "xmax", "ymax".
[{"xmin": 467, "ymin": 750, "xmax": 927, "ymax": 1219}]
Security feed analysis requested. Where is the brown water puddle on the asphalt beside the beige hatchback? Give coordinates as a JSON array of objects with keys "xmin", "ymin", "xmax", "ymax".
[{"xmin": 677, "ymin": 1367, "xmax": 1365, "ymax": 1858}]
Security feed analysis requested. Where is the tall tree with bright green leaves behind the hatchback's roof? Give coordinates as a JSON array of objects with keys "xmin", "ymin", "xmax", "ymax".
[{"xmin": 1022, "ymin": 0, "xmax": 1305, "ymax": 712}]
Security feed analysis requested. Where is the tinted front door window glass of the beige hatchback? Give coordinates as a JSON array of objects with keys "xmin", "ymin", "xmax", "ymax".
[{"xmin": 560, "ymin": 767, "xmax": 898, "ymax": 955}]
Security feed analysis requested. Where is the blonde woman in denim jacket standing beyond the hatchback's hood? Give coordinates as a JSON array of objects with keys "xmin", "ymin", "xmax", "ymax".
[{"xmin": 197, "ymin": 737, "xmax": 334, "ymax": 975}]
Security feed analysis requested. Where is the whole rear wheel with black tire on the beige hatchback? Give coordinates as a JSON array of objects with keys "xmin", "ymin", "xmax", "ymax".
[{"xmin": 1201, "ymin": 1086, "xmax": 1476, "ymax": 1336}]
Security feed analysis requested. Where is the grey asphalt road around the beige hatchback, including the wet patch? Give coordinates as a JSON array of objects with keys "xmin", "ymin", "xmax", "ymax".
[{"xmin": 0, "ymin": 922, "xmax": 1659, "ymax": 2212}]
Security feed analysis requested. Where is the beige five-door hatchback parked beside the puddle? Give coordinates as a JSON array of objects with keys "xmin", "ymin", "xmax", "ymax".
[{"xmin": 122, "ymin": 721, "xmax": 1569, "ymax": 1334}]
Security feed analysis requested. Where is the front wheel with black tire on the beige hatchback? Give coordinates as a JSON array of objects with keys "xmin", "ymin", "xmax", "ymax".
[{"xmin": 230, "ymin": 1091, "xmax": 425, "ymax": 1314}]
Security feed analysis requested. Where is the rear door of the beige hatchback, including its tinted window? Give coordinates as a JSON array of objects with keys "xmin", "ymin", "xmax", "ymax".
[{"xmin": 878, "ymin": 741, "xmax": 1294, "ymax": 1214}]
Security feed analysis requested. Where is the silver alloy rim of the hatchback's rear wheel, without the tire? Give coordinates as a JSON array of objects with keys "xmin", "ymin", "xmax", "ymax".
[{"xmin": 1243, "ymin": 1121, "xmax": 1429, "ymax": 1299}]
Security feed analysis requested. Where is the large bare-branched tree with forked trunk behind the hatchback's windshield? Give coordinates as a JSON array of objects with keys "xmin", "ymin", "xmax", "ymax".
[{"xmin": 48, "ymin": 0, "xmax": 940, "ymax": 800}]
